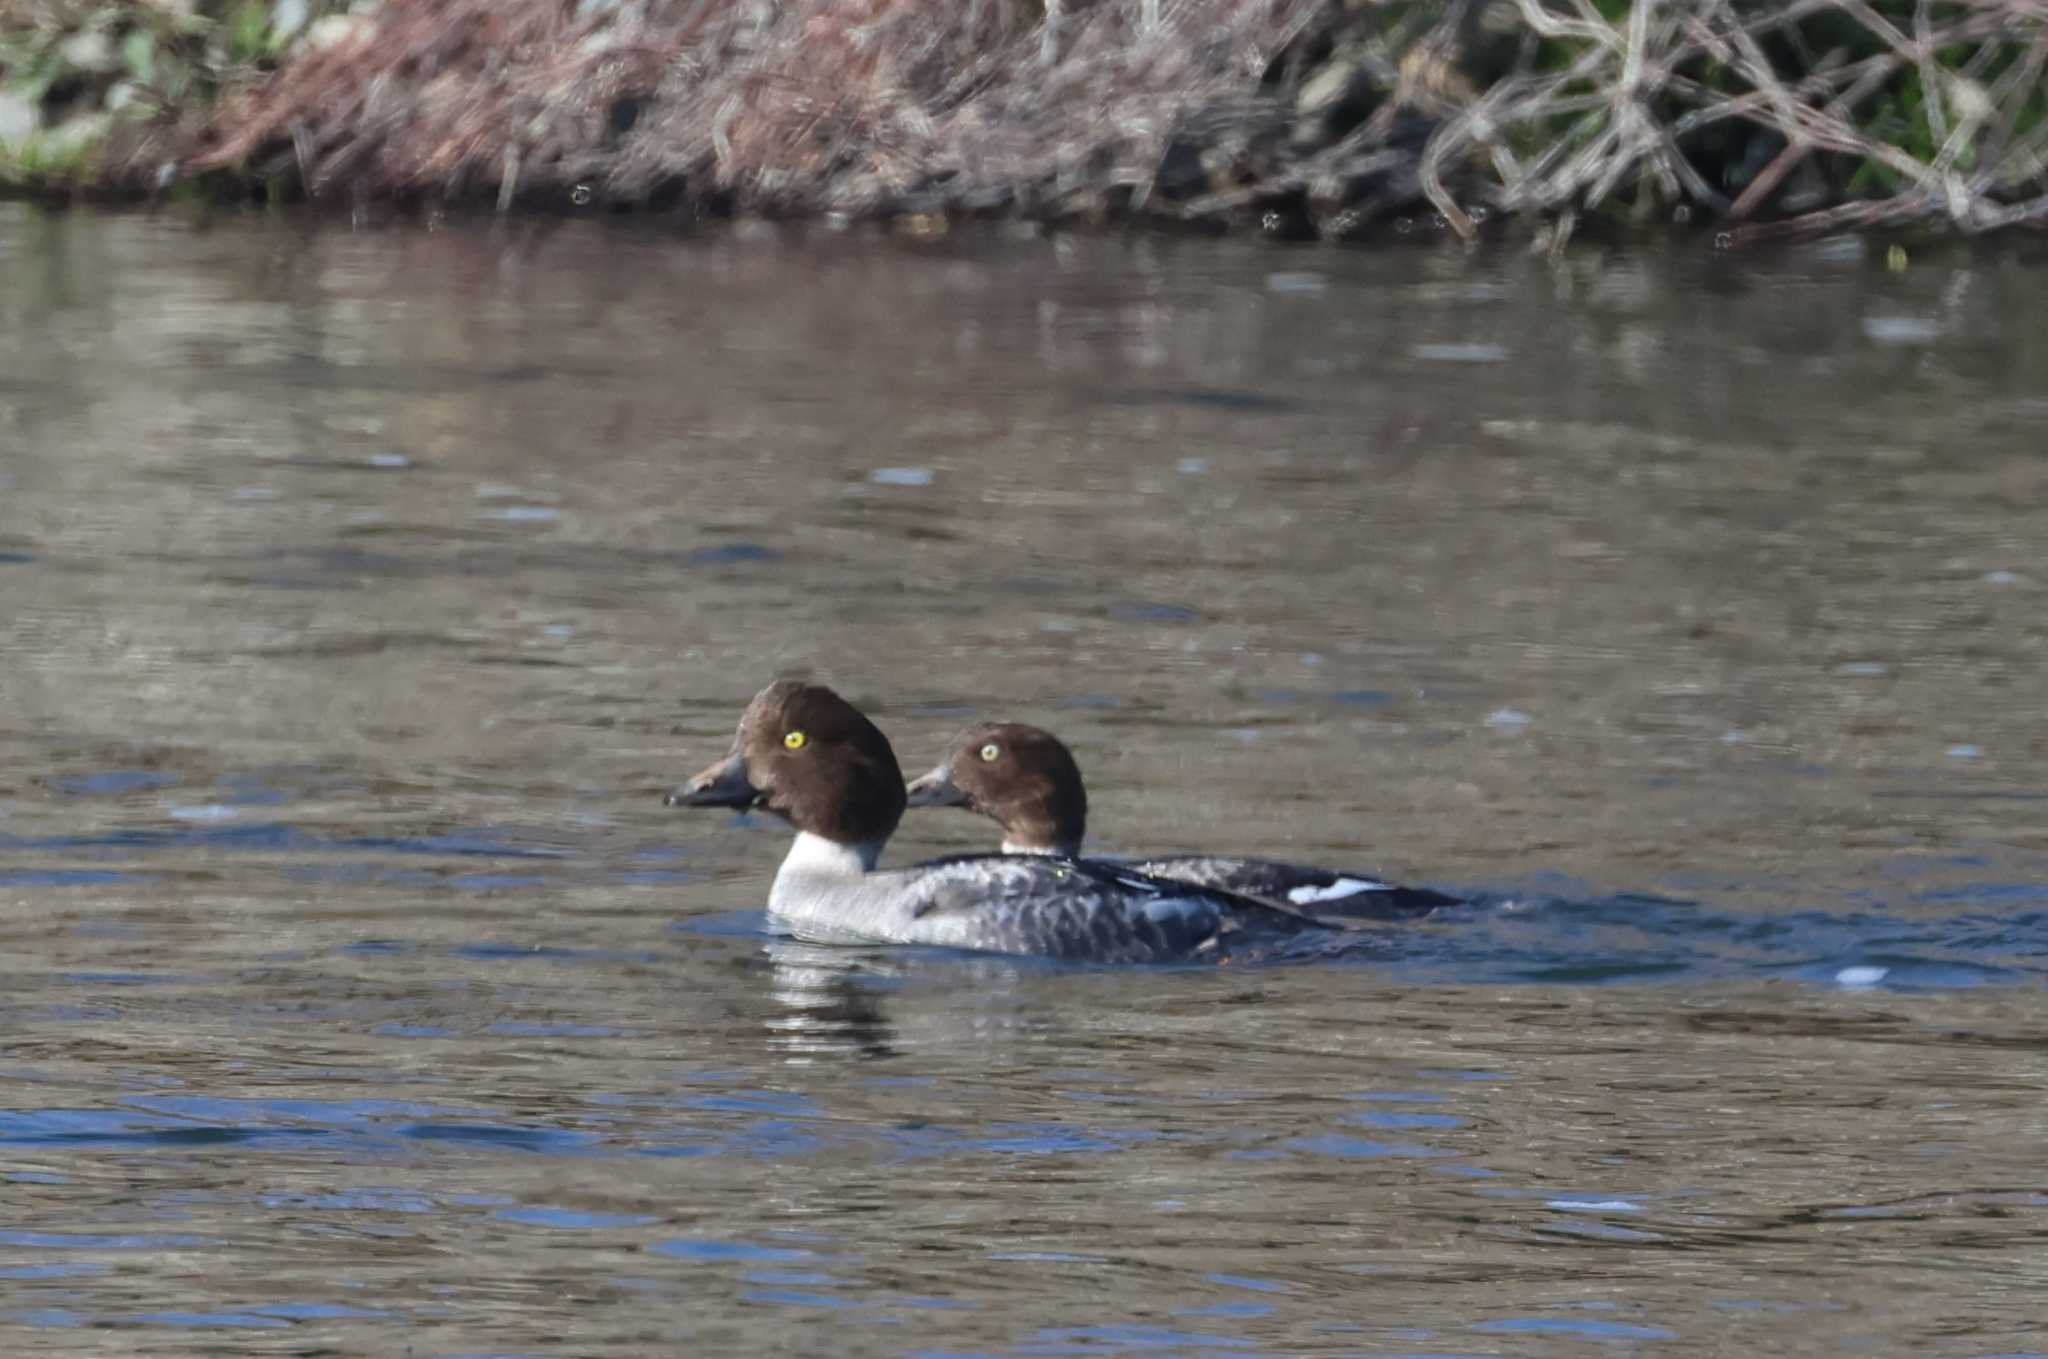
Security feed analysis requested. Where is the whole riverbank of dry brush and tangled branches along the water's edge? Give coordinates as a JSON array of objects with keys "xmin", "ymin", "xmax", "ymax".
[{"xmin": 0, "ymin": 0, "xmax": 2048, "ymax": 242}]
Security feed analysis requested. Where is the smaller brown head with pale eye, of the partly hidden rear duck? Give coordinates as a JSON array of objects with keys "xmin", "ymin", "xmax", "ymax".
[{"xmin": 909, "ymin": 722, "xmax": 1087, "ymax": 853}]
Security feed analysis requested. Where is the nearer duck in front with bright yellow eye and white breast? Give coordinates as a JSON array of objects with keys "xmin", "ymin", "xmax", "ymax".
[{"xmin": 666, "ymin": 680, "xmax": 1335, "ymax": 962}]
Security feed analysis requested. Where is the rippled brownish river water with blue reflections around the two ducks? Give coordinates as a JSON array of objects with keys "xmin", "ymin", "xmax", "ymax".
[{"xmin": 0, "ymin": 207, "xmax": 2048, "ymax": 1359}]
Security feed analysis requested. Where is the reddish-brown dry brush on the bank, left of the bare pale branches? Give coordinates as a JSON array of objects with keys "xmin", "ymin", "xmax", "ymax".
[{"xmin": 182, "ymin": 0, "xmax": 1425, "ymax": 227}]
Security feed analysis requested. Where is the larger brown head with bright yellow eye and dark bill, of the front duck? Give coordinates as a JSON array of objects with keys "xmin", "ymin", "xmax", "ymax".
[{"xmin": 668, "ymin": 680, "xmax": 903, "ymax": 847}]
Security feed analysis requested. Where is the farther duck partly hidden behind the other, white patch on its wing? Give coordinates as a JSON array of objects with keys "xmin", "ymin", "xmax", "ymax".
[{"xmin": 905, "ymin": 722, "xmax": 1464, "ymax": 923}]
